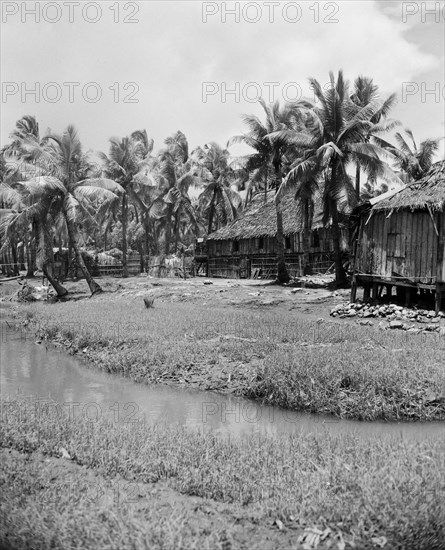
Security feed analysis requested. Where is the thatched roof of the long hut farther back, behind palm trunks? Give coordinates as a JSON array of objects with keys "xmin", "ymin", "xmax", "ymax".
[{"xmin": 207, "ymin": 191, "xmax": 316, "ymax": 241}]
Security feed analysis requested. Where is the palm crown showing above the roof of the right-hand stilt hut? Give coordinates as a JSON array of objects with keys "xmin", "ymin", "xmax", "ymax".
[{"xmin": 375, "ymin": 128, "xmax": 443, "ymax": 183}]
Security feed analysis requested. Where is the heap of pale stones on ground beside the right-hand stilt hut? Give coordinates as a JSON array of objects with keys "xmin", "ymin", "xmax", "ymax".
[{"xmin": 331, "ymin": 302, "xmax": 445, "ymax": 332}]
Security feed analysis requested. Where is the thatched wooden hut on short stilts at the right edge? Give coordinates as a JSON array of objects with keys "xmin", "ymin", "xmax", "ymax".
[{"xmin": 355, "ymin": 160, "xmax": 445, "ymax": 309}]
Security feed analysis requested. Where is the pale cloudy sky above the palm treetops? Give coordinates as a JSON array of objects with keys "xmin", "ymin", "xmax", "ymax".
[{"xmin": 0, "ymin": 0, "xmax": 445, "ymax": 158}]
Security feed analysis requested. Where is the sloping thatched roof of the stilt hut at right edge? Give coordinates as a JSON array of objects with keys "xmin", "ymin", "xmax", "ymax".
[{"xmin": 373, "ymin": 160, "xmax": 445, "ymax": 211}]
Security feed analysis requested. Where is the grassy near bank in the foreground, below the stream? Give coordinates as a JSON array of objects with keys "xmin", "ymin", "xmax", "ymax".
[{"xmin": 0, "ymin": 402, "xmax": 445, "ymax": 550}]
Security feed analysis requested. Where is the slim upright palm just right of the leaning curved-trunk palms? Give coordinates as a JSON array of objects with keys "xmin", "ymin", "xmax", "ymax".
[{"xmin": 99, "ymin": 130, "xmax": 153, "ymax": 277}]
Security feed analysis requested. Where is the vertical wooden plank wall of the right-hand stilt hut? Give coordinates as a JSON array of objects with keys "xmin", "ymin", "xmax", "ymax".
[{"xmin": 357, "ymin": 210, "xmax": 445, "ymax": 284}]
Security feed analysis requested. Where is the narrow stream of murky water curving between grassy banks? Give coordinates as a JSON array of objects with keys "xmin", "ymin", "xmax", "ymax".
[{"xmin": 0, "ymin": 323, "xmax": 445, "ymax": 440}]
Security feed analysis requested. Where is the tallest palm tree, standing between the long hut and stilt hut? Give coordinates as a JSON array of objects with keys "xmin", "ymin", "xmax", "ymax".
[{"xmin": 278, "ymin": 71, "xmax": 399, "ymax": 286}]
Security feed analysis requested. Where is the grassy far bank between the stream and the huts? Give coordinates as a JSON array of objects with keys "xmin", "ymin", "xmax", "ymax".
[{"xmin": 11, "ymin": 295, "xmax": 445, "ymax": 421}]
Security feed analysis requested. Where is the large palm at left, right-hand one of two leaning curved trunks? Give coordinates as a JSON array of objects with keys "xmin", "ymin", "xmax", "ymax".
[{"xmin": 12, "ymin": 125, "xmax": 123, "ymax": 295}]
